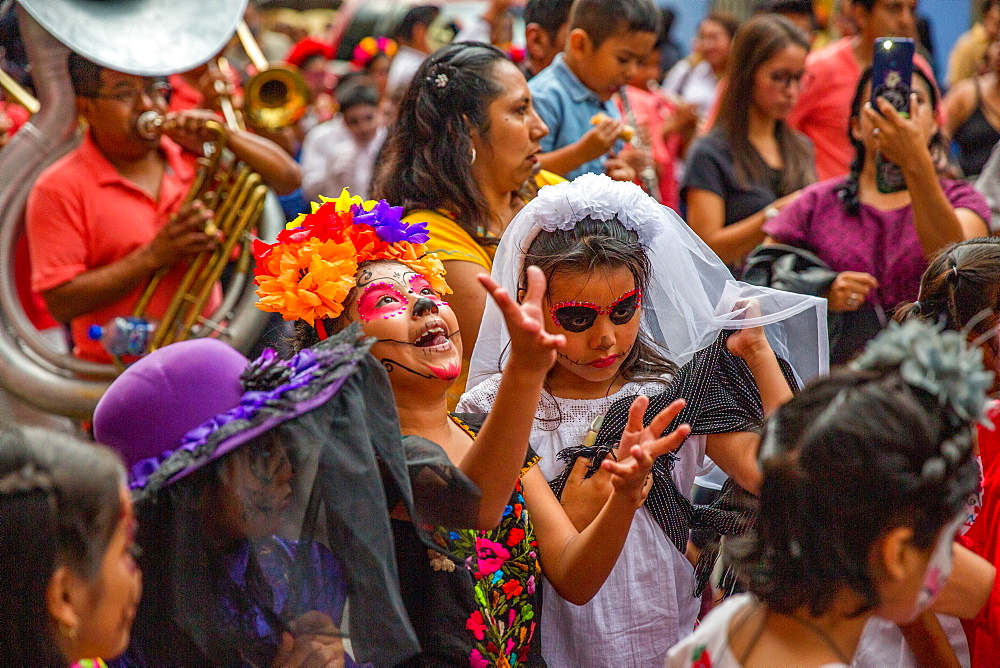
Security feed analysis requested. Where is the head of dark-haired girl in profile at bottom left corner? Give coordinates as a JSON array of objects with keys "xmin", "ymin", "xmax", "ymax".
[{"xmin": 0, "ymin": 427, "xmax": 142, "ymax": 666}]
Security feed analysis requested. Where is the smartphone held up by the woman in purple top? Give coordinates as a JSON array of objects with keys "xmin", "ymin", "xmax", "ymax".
[{"xmin": 871, "ymin": 37, "xmax": 915, "ymax": 193}]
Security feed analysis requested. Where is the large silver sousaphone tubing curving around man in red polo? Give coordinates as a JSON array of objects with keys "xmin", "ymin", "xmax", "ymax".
[{"xmin": 0, "ymin": 6, "xmax": 285, "ymax": 419}]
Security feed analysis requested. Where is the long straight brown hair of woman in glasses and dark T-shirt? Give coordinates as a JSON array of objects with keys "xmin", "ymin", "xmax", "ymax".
[{"xmin": 718, "ymin": 14, "xmax": 816, "ymax": 197}]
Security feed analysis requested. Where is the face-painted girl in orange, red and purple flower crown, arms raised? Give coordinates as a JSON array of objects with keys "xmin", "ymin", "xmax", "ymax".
[{"xmin": 249, "ymin": 191, "xmax": 688, "ymax": 668}]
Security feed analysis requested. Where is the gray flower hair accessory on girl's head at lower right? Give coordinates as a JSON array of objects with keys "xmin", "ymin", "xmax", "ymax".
[{"xmin": 851, "ymin": 319, "xmax": 993, "ymax": 428}]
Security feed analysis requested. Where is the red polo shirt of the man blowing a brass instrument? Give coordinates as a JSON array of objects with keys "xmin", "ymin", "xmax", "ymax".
[{"xmin": 26, "ymin": 133, "xmax": 222, "ymax": 362}]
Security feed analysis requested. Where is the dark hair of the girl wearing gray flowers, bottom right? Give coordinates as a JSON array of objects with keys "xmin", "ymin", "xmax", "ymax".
[{"xmin": 726, "ymin": 367, "xmax": 978, "ymax": 615}]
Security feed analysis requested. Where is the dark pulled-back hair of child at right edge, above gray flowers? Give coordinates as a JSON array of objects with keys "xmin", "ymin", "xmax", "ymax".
[{"xmin": 893, "ymin": 237, "xmax": 1000, "ymax": 336}]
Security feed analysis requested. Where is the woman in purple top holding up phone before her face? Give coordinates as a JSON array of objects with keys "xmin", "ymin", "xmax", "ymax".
[{"xmin": 757, "ymin": 68, "xmax": 989, "ymax": 364}]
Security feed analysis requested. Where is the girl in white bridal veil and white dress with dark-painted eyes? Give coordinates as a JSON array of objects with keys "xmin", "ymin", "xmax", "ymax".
[{"xmin": 458, "ymin": 175, "xmax": 827, "ymax": 666}]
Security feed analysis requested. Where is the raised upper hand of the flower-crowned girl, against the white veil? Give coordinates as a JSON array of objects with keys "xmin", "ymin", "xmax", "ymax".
[{"xmin": 478, "ymin": 266, "xmax": 566, "ymax": 376}]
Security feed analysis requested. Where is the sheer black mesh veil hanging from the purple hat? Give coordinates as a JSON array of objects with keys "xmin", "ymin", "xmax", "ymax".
[{"xmin": 120, "ymin": 340, "xmax": 420, "ymax": 666}]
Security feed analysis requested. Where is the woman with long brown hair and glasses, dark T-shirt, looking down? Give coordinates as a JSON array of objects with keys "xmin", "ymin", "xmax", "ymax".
[{"xmin": 681, "ymin": 14, "xmax": 816, "ymax": 267}]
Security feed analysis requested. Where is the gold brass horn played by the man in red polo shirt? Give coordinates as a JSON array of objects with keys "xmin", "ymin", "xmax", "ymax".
[{"xmin": 132, "ymin": 111, "xmax": 267, "ymax": 352}]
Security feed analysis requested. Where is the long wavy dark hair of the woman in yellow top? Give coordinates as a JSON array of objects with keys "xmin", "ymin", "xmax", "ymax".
[{"xmin": 372, "ymin": 42, "xmax": 509, "ymax": 245}]
